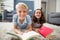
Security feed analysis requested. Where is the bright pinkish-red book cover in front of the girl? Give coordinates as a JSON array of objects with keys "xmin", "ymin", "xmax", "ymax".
[{"xmin": 39, "ymin": 26, "xmax": 53, "ymax": 38}]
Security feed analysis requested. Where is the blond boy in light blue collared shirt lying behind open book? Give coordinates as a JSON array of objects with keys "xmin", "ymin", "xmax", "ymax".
[{"xmin": 13, "ymin": 3, "xmax": 32, "ymax": 34}]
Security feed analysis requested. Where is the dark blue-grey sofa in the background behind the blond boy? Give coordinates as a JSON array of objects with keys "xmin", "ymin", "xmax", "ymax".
[{"xmin": 4, "ymin": 10, "xmax": 33, "ymax": 22}]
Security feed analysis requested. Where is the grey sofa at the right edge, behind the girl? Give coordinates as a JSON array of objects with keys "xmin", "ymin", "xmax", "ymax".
[{"xmin": 47, "ymin": 12, "xmax": 60, "ymax": 25}]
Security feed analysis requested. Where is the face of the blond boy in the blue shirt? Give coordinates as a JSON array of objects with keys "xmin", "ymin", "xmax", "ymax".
[{"xmin": 16, "ymin": 6, "xmax": 27, "ymax": 19}]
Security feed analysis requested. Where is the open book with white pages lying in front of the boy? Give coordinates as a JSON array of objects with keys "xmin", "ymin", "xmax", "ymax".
[{"xmin": 8, "ymin": 31, "xmax": 42, "ymax": 40}]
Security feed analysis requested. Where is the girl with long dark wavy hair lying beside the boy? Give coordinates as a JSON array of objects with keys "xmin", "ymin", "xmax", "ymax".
[{"xmin": 32, "ymin": 9, "xmax": 45, "ymax": 32}]
